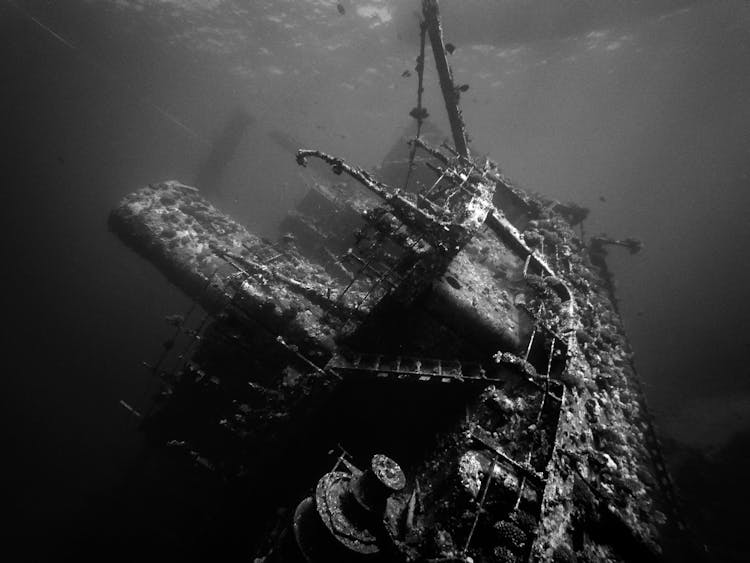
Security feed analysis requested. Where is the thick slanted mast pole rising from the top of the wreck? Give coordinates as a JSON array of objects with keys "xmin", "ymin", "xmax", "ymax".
[{"xmin": 422, "ymin": 0, "xmax": 469, "ymax": 158}]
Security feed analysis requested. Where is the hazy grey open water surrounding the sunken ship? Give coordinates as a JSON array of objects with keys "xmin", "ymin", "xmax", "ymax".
[{"xmin": 0, "ymin": 0, "xmax": 750, "ymax": 561}]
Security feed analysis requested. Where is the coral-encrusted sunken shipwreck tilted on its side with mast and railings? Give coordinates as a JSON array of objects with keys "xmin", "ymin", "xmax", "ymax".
[{"xmin": 110, "ymin": 0, "xmax": 700, "ymax": 562}]
